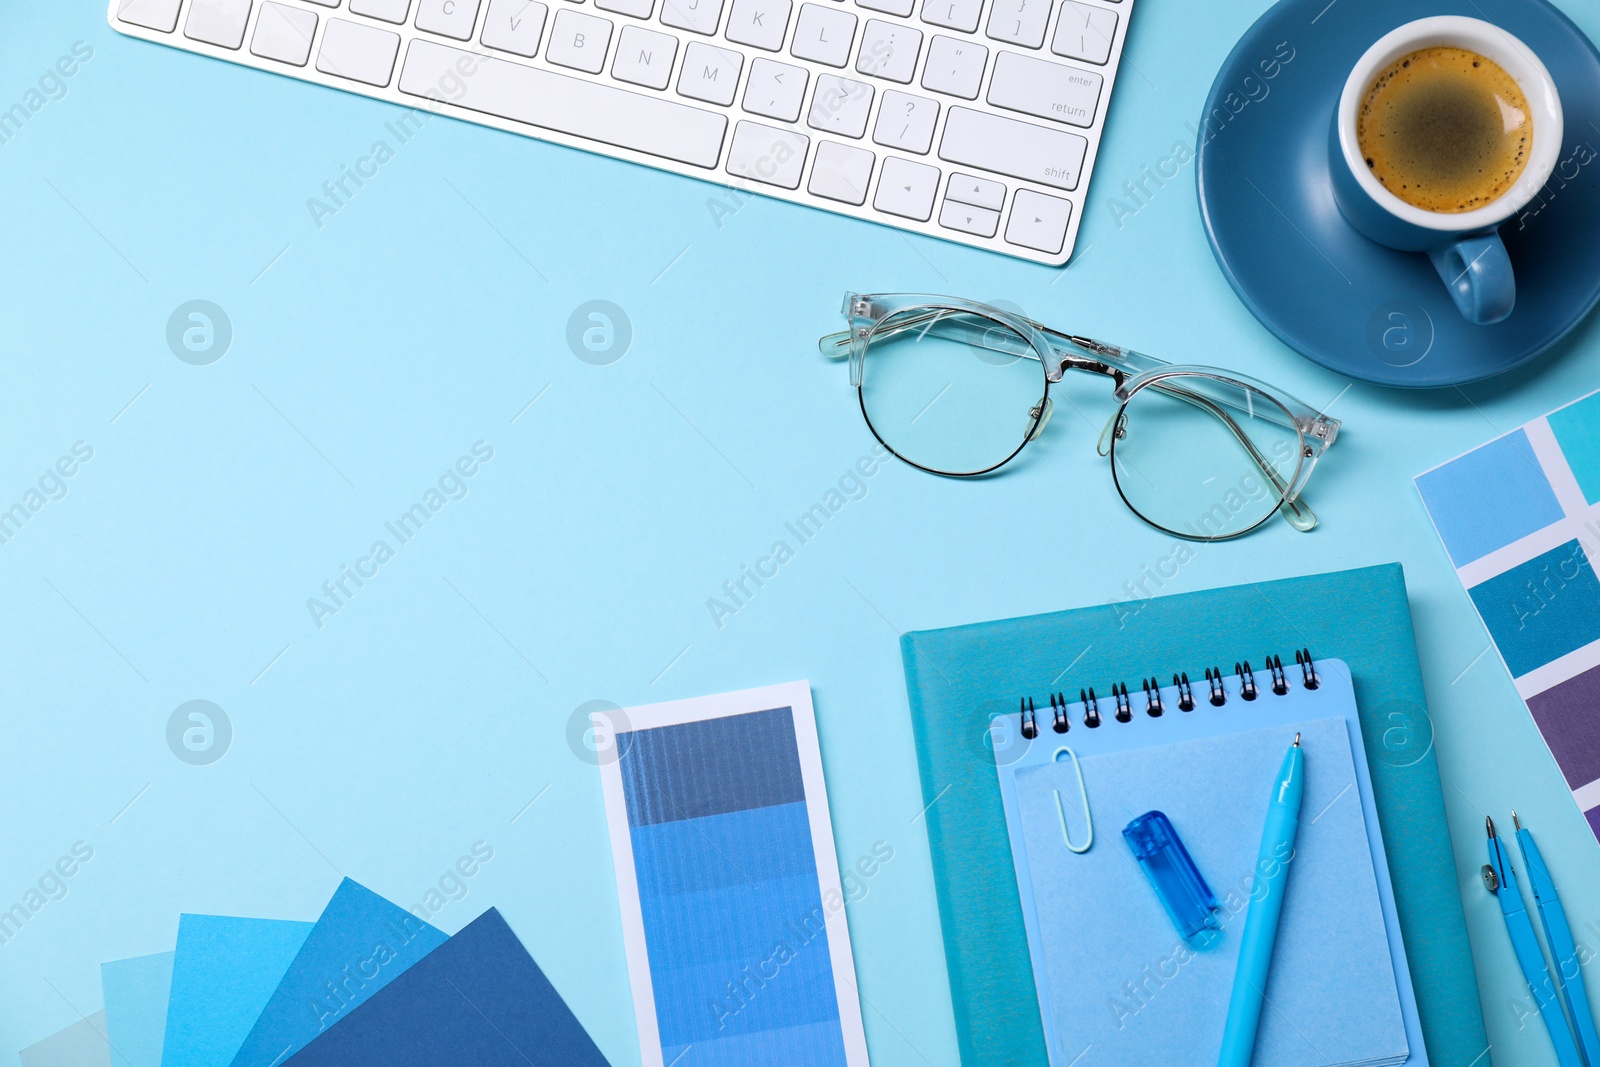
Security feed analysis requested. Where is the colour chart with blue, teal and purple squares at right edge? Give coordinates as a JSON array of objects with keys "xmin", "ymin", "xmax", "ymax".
[{"xmin": 1416, "ymin": 394, "xmax": 1600, "ymax": 837}]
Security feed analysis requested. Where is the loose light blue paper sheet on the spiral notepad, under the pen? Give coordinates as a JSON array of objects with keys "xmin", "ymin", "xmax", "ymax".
[{"xmin": 1016, "ymin": 718, "xmax": 1408, "ymax": 1067}]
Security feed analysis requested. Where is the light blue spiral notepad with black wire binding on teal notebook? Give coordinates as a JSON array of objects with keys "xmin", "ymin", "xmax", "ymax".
[{"xmin": 990, "ymin": 654, "xmax": 1426, "ymax": 1067}]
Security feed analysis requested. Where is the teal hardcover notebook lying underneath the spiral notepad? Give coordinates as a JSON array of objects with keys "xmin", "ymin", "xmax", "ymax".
[{"xmin": 901, "ymin": 565, "xmax": 1488, "ymax": 1067}]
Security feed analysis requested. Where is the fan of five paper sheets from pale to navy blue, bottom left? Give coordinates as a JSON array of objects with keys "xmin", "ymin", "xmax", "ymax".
[{"xmin": 21, "ymin": 878, "xmax": 608, "ymax": 1067}]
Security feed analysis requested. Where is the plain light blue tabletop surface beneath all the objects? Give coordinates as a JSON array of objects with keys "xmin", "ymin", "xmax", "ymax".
[{"xmin": 0, "ymin": 0, "xmax": 1600, "ymax": 1067}]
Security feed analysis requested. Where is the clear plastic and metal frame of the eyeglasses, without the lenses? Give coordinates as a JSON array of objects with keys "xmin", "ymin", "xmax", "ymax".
[{"xmin": 818, "ymin": 293, "xmax": 1341, "ymax": 541}]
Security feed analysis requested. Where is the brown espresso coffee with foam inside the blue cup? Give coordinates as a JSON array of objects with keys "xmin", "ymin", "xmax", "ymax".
[{"xmin": 1355, "ymin": 46, "xmax": 1533, "ymax": 214}]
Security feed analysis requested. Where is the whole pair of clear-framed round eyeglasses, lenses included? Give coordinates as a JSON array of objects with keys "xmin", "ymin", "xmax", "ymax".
[{"xmin": 818, "ymin": 293, "xmax": 1339, "ymax": 541}]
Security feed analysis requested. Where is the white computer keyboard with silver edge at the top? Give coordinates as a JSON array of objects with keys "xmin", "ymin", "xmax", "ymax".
[{"xmin": 109, "ymin": 0, "xmax": 1133, "ymax": 264}]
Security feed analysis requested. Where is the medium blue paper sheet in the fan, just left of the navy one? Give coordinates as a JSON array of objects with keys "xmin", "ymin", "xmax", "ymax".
[{"xmin": 232, "ymin": 878, "xmax": 446, "ymax": 1067}]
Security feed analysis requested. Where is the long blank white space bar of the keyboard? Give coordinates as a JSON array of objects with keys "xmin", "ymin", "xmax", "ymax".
[{"xmin": 400, "ymin": 40, "xmax": 728, "ymax": 166}]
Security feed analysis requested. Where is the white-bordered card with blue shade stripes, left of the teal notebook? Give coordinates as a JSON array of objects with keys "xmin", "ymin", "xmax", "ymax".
[{"xmin": 595, "ymin": 683, "xmax": 867, "ymax": 1067}]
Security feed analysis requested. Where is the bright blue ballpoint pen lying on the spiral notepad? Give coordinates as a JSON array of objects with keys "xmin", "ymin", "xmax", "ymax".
[{"xmin": 1216, "ymin": 734, "xmax": 1306, "ymax": 1067}]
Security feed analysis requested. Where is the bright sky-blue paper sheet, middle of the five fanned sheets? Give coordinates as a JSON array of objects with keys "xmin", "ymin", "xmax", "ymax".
[{"xmin": 162, "ymin": 915, "xmax": 312, "ymax": 1067}]
